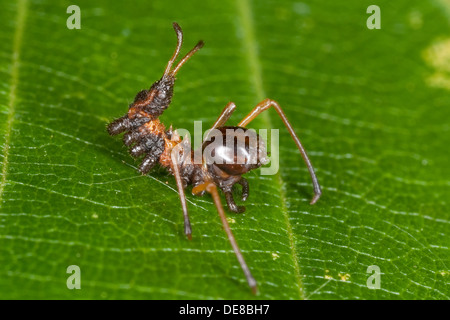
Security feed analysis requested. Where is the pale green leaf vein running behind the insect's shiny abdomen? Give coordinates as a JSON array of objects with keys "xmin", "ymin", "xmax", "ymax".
[{"xmin": 236, "ymin": 0, "xmax": 305, "ymax": 300}]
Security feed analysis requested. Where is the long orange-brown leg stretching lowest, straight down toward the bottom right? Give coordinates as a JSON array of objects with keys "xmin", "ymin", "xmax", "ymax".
[{"xmin": 192, "ymin": 182, "xmax": 258, "ymax": 294}]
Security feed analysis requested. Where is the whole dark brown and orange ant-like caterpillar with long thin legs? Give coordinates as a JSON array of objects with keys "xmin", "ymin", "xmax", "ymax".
[{"xmin": 108, "ymin": 23, "xmax": 322, "ymax": 293}]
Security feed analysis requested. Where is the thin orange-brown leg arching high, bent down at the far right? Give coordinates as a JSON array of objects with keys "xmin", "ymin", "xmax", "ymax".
[{"xmin": 238, "ymin": 99, "xmax": 322, "ymax": 204}]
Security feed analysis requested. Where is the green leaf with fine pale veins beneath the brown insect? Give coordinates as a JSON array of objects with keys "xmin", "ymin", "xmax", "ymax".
[{"xmin": 0, "ymin": 0, "xmax": 450, "ymax": 299}]
